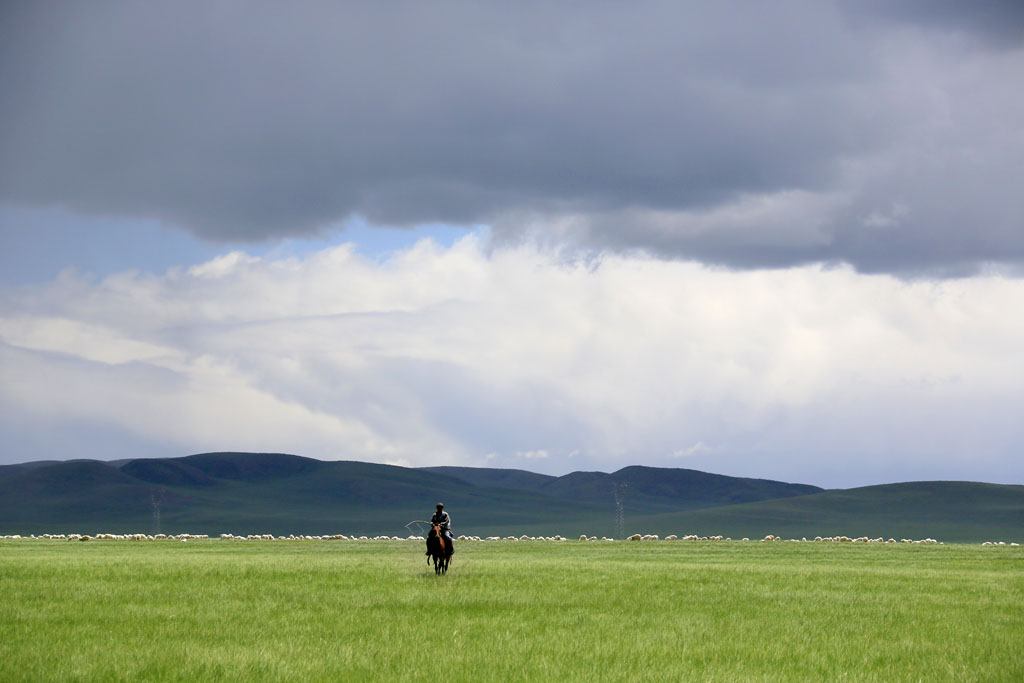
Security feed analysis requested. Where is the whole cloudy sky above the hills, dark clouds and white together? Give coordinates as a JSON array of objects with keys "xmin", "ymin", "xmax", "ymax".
[{"xmin": 0, "ymin": 0, "xmax": 1024, "ymax": 486}]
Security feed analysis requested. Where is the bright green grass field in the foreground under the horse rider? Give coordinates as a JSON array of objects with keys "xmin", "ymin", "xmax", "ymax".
[{"xmin": 0, "ymin": 540, "xmax": 1024, "ymax": 681}]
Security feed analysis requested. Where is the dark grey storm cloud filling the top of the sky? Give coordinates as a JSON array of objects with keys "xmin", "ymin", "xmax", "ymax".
[{"xmin": 0, "ymin": 2, "xmax": 1024, "ymax": 270}]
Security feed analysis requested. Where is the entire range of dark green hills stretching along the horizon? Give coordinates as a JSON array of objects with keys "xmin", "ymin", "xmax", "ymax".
[{"xmin": 0, "ymin": 453, "xmax": 1024, "ymax": 541}]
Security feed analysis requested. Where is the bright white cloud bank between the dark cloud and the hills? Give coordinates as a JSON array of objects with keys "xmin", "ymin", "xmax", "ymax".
[{"xmin": 0, "ymin": 237, "xmax": 1024, "ymax": 485}]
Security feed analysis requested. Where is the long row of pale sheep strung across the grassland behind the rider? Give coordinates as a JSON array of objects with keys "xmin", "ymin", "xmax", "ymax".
[{"xmin": 0, "ymin": 533, "xmax": 1020, "ymax": 547}]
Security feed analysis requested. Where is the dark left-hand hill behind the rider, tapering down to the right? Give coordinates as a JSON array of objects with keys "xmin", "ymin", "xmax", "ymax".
[{"xmin": 0, "ymin": 454, "xmax": 600, "ymax": 536}]
